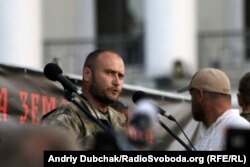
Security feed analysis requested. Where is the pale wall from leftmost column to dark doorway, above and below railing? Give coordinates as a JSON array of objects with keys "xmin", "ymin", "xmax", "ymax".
[{"xmin": 43, "ymin": 0, "xmax": 96, "ymax": 74}]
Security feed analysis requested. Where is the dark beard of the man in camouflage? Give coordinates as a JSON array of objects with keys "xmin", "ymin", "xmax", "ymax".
[{"xmin": 90, "ymin": 75, "xmax": 118, "ymax": 105}]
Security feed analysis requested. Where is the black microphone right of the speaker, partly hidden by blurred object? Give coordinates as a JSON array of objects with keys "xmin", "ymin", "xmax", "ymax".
[{"xmin": 132, "ymin": 91, "xmax": 176, "ymax": 121}]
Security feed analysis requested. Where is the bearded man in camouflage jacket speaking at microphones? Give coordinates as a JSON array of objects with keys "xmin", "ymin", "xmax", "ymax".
[{"xmin": 41, "ymin": 50, "xmax": 129, "ymax": 150}]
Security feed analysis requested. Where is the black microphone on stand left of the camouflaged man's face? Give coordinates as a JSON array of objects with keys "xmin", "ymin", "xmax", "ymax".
[{"xmin": 43, "ymin": 63, "xmax": 83, "ymax": 96}]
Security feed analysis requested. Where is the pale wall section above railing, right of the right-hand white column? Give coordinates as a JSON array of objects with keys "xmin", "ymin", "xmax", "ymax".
[{"xmin": 197, "ymin": 0, "xmax": 243, "ymax": 32}]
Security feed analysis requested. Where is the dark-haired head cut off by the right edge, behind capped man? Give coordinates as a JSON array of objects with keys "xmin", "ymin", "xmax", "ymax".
[{"xmin": 238, "ymin": 72, "xmax": 250, "ymax": 104}]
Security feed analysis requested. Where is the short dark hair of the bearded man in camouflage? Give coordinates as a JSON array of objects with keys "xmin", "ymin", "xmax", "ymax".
[{"xmin": 84, "ymin": 49, "xmax": 116, "ymax": 68}]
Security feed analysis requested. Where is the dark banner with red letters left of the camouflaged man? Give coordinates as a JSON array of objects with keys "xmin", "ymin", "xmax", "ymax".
[{"xmin": 0, "ymin": 64, "xmax": 66, "ymax": 125}]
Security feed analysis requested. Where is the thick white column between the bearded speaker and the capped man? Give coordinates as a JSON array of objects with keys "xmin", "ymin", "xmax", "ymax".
[{"xmin": 144, "ymin": 0, "xmax": 197, "ymax": 78}]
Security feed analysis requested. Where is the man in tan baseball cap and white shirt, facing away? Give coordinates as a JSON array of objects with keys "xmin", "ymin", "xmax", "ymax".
[{"xmin": 178, "ymin": 68, "xmax": 250, "ymax": 151}]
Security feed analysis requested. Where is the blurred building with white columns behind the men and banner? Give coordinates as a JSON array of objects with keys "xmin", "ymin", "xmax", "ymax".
[{"xmin": 0, "ymin": 0, "xmax": 250, "ymax": 91}]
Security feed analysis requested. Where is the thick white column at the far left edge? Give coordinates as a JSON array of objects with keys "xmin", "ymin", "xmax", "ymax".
[{"xmin": 0, "ymin": 0, "xmax": 42, "ymax": 69}]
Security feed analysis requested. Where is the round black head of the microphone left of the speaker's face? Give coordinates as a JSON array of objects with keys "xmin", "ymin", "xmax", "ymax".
[{"xmin": 43, "ymin": 63, "xmax": 62, "ymax": 81}]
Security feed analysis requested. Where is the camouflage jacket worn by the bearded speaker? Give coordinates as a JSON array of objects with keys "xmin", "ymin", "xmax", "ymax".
[{"xmin": 42, "ymin": 96, "xmax": 126, "ymax": 150}]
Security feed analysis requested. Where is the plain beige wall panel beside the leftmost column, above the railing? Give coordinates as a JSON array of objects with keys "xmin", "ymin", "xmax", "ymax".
[{"xmin": 43, "ymin": 0, "xmax": 78, "ymax": 39}]
